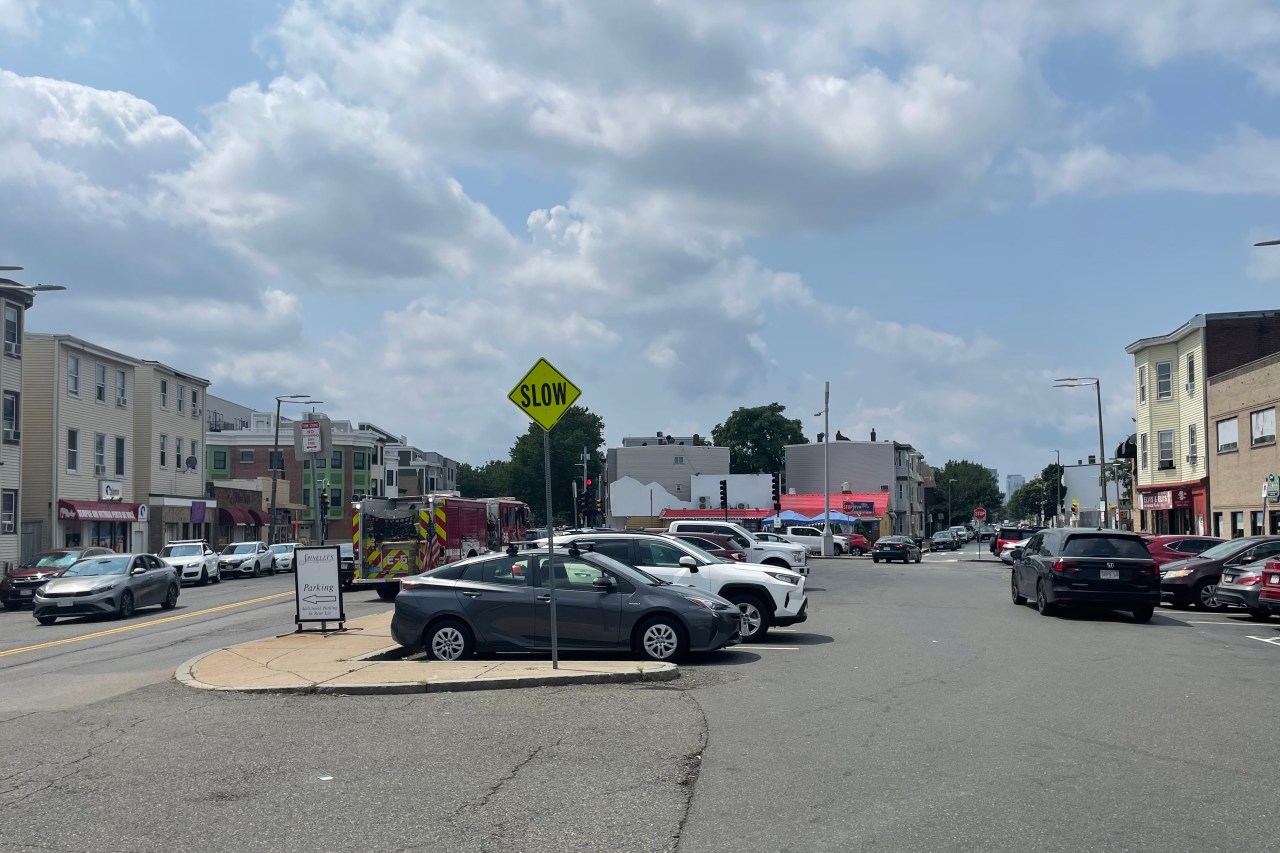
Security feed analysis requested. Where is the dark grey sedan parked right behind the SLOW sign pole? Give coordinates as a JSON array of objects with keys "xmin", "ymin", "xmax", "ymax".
[{"xmin": 392, "ymin": 545, "xmax": 742, "ymax": 662}]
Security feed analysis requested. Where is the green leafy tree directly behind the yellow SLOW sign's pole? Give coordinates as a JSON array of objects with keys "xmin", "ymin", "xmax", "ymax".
[{"xmin": 507, "ymin": 406, "xmax": 604, "ymax": 521}]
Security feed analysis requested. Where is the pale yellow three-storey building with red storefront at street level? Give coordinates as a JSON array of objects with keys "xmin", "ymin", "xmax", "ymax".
[{"xmin": 1125, "ymin": 310, "xmax": 1280, "ymax": 534}]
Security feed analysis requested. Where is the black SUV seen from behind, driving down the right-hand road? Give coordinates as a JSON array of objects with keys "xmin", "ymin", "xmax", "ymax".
[{"xmin": 1011, "ymin": 528, "xmax": 1160, "ymax": 622}]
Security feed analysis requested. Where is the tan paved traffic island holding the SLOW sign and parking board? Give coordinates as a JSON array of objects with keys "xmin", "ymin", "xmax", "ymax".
[{"xmin": 183, "ymin": 611, "xmax": 678, "ymax": 694}]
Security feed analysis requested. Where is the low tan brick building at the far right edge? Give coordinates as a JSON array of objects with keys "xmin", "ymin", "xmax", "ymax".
[{"xmin": 1206, "ymin": 353, "xmax": 1280, "ymax": 539}]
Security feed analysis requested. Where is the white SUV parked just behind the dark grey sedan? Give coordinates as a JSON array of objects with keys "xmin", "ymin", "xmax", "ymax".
[{"xmin": 543, "ymin": 533, "xmax": 809, "ymax": 642}]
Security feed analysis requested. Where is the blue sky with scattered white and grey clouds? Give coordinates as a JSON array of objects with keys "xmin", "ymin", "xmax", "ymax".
[{"xmin": 0, "ymin": 0, "xmax": 1280, "ymax": 487}]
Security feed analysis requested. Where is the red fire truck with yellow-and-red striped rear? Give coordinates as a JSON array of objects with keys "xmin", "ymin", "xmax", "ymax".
[{"xmin": 351, "ymin": 494, "xmax": 529, "ymax": 601}]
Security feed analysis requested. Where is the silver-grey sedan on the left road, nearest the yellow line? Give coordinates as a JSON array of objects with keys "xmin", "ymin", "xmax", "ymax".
[{"xmin": 33, "ymin": 553, "xmax": 180, "ymax": 625}]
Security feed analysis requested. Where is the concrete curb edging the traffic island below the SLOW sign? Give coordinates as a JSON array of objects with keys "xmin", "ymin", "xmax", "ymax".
[{"xmin": 174, "ymin": 648, "xmax": 680, "ymax": 695}]
